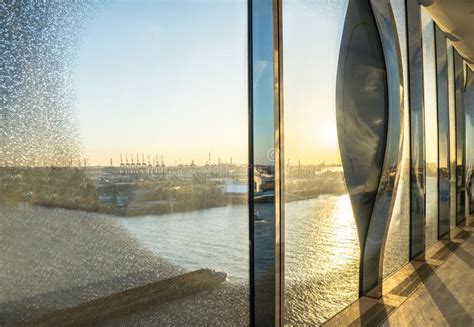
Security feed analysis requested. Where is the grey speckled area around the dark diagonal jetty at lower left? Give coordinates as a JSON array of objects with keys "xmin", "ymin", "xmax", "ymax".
[{"xmin": 0, "ymin": 204, "xmax": 248, "ymax": 326}]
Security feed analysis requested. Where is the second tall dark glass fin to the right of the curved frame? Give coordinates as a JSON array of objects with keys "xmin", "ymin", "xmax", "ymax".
[{"xmin": 435, "ymin": 25, "xmax": 450, "ymax": 238}]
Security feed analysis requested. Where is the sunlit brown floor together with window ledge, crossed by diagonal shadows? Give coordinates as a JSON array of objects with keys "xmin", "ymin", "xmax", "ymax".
[{"xmin": 324, "ymin": 223, "xmax": 474, "ymax": 327}]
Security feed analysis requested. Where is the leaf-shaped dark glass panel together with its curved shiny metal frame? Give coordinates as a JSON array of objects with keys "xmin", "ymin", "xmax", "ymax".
[{"xmin": 336, "ymin": 0, "xmax": 403, "ymax": 296}]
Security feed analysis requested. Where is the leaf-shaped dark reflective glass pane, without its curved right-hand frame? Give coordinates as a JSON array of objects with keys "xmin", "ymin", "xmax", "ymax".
[{"xmin": 336, "ymin": 1, "xmax": 387, "ymax": 262}]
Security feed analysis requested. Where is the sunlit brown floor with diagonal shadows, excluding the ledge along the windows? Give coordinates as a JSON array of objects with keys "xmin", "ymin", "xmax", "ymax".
[{"xmin": 382, "ymin": 228, "xmax": 474, "ymax": 326}]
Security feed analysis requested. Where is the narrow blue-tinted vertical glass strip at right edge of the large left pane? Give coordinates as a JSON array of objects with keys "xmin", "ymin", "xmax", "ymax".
[{"xmin": 251, "ymin": 0, "xmax": 278, "ymax": 326}]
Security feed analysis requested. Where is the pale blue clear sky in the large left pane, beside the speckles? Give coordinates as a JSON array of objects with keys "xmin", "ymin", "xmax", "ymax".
[{"xmin": 76, "ymin": 0, "xmax": 247, "ymax": 164}]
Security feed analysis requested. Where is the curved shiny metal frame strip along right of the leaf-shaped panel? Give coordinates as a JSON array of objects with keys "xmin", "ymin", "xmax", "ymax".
[{"xmin": 361, "ymin": 0, "xmax": 404, "ymax": 297}]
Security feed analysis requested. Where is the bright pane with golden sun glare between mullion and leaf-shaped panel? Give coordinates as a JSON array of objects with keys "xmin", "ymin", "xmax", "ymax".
[{"xmin": 283, "ymin": 0, "xmax": 360, "ymax": 326}]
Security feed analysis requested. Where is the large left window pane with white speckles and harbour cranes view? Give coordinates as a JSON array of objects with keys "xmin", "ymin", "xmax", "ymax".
[{"xmin": 0, "ymin": 0, "xmax": 249, "ymax": 326}]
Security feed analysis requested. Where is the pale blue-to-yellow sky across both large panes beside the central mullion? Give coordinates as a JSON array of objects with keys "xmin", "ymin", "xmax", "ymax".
[{"xmin": 75, "ymin": 0, "xmax": 347, "ymax": 165}]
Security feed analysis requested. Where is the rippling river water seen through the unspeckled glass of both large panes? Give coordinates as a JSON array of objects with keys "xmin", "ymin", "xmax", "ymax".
[{"xmin": 118, "ymin": 195, "xmax": 359, "ymax": 325}]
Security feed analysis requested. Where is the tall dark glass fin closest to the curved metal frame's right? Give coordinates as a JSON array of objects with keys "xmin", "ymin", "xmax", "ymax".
[{"xmin": 406, "ymin": 0, "xmax": 425, "ymax": 258}]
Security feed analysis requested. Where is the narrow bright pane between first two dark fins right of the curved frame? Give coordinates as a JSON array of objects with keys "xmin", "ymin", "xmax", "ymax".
[{"xmin": 421, "ymin": 7, "xmax": 438, "ymax": 247}]
